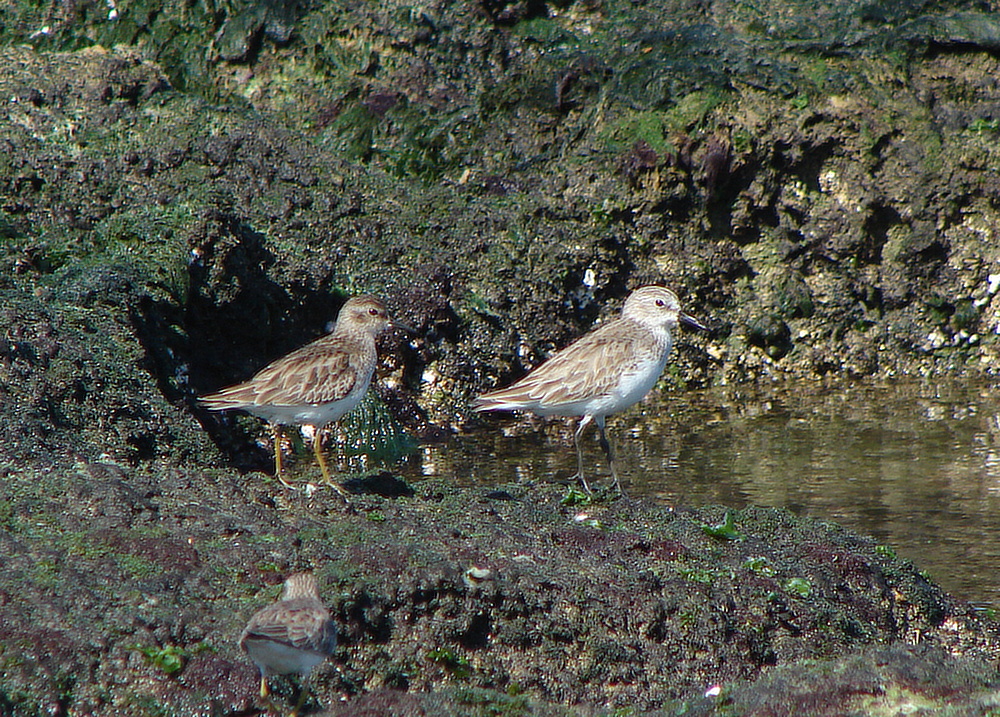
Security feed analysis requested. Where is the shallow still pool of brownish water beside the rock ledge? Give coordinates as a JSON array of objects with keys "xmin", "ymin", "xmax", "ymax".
[{"xmin": 394, "ymin": 382, "xmax": 1000, "ymax": 608}]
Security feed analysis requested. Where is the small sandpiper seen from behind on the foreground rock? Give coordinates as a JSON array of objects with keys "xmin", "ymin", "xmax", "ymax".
[{"xmin": 239, "ymin": 572, "xmax": 337, "ymax": 715}]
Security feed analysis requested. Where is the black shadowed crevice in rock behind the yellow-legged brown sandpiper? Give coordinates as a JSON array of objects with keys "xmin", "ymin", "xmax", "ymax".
[{"xmin": 132, "ymin": 211, "xmax": 348, "ymax": 471}]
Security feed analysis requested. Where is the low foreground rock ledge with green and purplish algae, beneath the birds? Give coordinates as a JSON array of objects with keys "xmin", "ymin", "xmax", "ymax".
[{"xmin": 0, "ymin": 472, "xmax": 1000, "ymax": 715}]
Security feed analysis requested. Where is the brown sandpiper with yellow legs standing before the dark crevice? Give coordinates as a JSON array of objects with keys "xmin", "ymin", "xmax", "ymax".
[{"xmin": 199, "ymin": 296, "xmax": 408, "ymax": 493}]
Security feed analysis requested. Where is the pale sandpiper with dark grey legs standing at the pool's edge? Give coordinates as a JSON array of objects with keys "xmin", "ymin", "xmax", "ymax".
[{"xmin": 472, "ymin": 286, "xmax": 707, "ymax": 493}]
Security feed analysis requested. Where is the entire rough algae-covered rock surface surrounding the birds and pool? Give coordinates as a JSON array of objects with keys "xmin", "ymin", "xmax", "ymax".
[{"xmin": 0, "ymin": 0, "xmax": 1000, "ymax": 715}]
